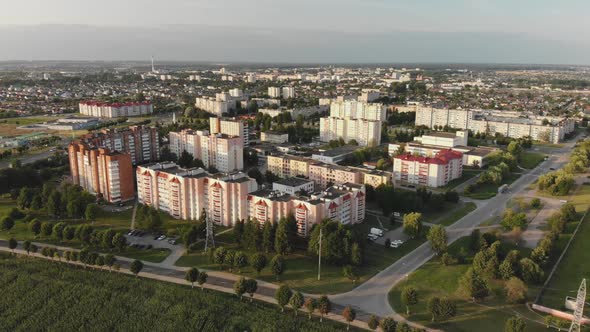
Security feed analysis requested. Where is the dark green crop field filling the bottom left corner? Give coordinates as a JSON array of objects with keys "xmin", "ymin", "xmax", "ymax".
[{"xmin": 0, "ymin": 254, "xmax": 356, "ymax": 332}]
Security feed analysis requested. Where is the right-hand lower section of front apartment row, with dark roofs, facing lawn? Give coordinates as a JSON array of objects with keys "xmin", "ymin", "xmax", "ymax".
[{"xmin": 248, "ymin": 183, "xmax": 365, "ymax": 237}]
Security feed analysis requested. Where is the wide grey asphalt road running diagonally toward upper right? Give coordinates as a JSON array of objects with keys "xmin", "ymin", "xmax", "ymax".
[{"xmin": 330, "ymin": 137, "xmax": 575, "ymax": 320}]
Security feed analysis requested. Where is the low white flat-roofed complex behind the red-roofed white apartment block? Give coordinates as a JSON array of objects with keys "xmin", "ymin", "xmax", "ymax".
[{"xmin": 389, "ymin": 130, "xmax": 499, "ymax": 167}]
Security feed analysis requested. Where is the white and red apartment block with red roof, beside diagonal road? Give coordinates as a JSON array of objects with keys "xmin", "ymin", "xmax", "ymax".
[{"xmin": 393, "ymin": 149, "xmax": 463, "ymax": 188}]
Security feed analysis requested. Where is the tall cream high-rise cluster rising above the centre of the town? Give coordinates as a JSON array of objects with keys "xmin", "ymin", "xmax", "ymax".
[{"xmin": 320, "ymin": 100, "xmax": 386, "ymax": 146}]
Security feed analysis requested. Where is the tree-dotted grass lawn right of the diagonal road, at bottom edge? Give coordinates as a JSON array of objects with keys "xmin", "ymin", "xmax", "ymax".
[{"xmin": 389, "ymin": 237, "xmax": 543, "ymax": 332}]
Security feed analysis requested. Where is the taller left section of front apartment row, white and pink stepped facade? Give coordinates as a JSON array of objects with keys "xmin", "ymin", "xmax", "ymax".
[{"xmin": 136, "ymin": 162, "xmax": 258, "ymax": 227}]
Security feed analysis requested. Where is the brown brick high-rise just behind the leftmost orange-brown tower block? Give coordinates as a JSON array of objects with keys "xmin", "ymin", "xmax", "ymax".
[{"xmin": 80, "ymin": 126, "xmax": 160, "ymax": 165}]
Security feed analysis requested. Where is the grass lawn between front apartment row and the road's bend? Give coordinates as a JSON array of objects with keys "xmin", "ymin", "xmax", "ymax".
[{"xmin": 176, "ymin": 223, "xmax": 425, "ymax": 294}]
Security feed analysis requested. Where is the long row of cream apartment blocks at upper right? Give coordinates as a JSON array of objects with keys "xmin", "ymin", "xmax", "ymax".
[{"xmin": 416, "ymin": 107, "xmax": 575, "ymax": 143}]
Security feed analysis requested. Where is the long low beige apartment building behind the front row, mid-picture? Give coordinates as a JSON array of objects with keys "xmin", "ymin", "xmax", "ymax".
[{"xmin": 267, "ymin": 155, "xmax": 391, "ymax": 190}]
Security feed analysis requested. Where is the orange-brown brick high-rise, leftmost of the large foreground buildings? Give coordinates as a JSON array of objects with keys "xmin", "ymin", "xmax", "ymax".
[{"xmin": 68, "ymin": 142, "xmax": 135, "ymax": 203}]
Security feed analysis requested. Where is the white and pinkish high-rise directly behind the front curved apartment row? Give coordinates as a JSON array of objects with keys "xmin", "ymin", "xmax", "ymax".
[{"xmin": 169, "ymin": 129, "xmax": 244, "ymax": 173}]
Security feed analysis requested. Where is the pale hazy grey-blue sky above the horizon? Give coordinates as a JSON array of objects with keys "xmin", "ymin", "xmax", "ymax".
[{"xmin": 0, "ymin": 0, "xmax": 590, "ymax": 64}]
